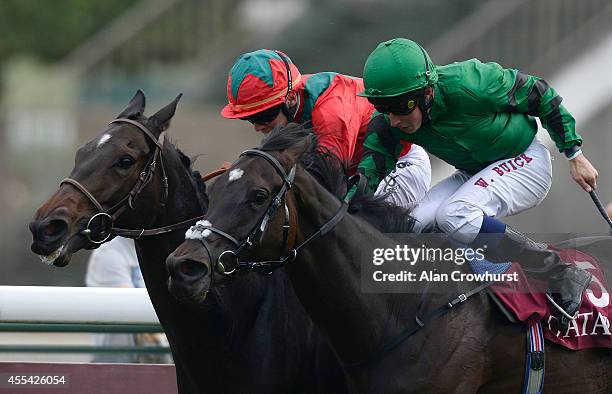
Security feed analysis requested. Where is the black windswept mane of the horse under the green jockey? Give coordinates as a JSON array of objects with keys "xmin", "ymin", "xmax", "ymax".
[{"xmin": 259, "ymin": 123, "xmax": 413, "ymax": 233}]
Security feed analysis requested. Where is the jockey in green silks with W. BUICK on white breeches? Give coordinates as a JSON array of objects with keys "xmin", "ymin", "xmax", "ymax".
[{"xmin": 358, "ymin": 38, "xmax": 597, "ymax": 326}]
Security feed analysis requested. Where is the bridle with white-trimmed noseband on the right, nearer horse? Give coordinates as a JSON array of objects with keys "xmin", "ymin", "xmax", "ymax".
[{"xmin": 191, "ymin": 149, "xmax": 348, "ymax": 275}]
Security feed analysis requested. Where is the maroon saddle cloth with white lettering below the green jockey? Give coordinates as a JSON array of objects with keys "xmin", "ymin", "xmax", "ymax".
[{"xmin": 470, "ymin": 246, "xmax": 612, "ymax": 350}]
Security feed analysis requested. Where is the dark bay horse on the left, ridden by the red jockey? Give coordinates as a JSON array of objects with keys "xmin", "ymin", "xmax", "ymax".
[{"xmin": 30, "ymin": 91, "xmax": 347, "ymax": 393}]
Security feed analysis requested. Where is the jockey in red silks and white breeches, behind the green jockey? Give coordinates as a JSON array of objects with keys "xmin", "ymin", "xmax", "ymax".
[{"xmin": 221, "ymin": 49, "xmax": 431, "ymax": 205}]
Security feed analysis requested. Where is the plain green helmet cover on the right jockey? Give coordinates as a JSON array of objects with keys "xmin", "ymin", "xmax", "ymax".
[{"xmin": 358, "ymin": 38, "xmax": 438, "ymax": 97}]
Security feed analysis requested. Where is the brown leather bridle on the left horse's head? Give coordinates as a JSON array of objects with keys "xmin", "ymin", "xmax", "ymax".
[{"xmin": 60, "ymin": 118, "xmax": 204, "ymax": 245}]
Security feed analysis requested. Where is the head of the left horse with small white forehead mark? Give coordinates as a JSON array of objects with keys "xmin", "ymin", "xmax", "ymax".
[{"xmin": 29, "ymin": 90, "xmax": 181, "ymax": 266}]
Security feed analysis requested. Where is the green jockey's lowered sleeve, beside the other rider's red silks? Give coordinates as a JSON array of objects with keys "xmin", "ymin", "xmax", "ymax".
[{"xmin": 357, "ymin": 112, "xmax": 401, "ymax": 194}]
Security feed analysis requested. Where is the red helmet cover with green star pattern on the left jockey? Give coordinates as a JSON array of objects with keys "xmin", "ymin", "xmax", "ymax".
[{"xmin": 221, "ymin": 49, "xmax": 302, "ymax": 119}]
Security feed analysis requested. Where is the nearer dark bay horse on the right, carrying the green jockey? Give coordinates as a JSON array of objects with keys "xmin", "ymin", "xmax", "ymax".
[{"xmin": 167, "ymin": 126, "xmax": 612, "ymax": 394}]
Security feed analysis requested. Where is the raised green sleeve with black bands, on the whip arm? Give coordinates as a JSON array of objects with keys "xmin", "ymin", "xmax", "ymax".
[{"xmin": 478, "ymin": 63, "xmax": 582, "ymax": 152}]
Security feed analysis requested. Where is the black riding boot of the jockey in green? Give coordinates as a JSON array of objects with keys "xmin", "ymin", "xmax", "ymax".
[{"xmin": 484, "ymin": 226, "xmax": 592, "ymax": 331}]
